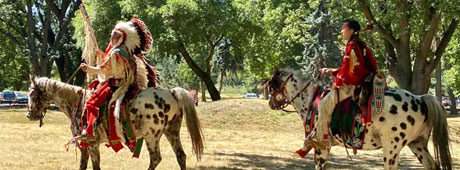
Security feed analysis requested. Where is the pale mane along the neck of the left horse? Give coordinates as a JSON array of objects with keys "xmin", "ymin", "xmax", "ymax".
[{"xmin": 35, "ymin": 77, "xmax": 82, "ymax": 97}]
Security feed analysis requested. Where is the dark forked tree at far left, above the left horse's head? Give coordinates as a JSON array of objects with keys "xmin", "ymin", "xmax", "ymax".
[{"xmin": 0, "ymin": 0, "xmax": 80, "ymax": 81}]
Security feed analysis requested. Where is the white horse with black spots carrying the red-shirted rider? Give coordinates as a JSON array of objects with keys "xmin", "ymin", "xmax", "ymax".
[{"xmin": 269, "ymin": 69, "xmax": 452, "ymax": 170}]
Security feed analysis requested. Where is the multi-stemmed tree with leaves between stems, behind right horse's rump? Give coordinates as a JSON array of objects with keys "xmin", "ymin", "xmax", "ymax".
[{"xmin": 358, "ymin": 0, "xmax": 460, "ymax": 94}]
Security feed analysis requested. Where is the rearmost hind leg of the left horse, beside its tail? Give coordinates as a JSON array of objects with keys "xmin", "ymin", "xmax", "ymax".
[{"xmin": 165, "ymin": 116, "xmax": 187, "ymax": 170}]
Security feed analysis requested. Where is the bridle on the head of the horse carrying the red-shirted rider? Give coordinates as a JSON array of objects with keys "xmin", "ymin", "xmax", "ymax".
[{"xmin": 271, "ymin": 73, "xmax": 311, "ymax": 112}]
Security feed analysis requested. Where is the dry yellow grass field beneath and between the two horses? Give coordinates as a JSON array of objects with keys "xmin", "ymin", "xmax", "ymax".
[{"xmin": 0, "ymin": 99, "xmax": 460, "ymax": 170}]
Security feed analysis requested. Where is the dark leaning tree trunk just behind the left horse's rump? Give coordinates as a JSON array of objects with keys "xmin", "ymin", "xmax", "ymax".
[{"xmin": 178, "ymin": 42, "xmax": 220, "ymax": 101}]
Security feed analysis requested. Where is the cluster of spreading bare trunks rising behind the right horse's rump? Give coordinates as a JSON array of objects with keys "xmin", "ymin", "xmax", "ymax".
[{"xmin": 358, "ymin": 0, "xmax": 459, "ymax": 95}]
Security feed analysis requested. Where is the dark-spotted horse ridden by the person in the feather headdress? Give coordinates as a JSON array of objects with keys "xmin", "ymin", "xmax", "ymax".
[{"xmin": 27, "ymin": 78, "xmax": 204, "ymax": 169}]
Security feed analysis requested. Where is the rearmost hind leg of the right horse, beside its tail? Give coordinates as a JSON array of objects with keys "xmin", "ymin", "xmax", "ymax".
[{"xmin": 409, "ymin": 137, "xmax": 436, "ymax": 169}]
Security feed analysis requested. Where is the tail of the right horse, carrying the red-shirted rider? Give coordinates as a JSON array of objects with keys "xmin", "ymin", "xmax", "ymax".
[{"xmin": 422, "ymin": 95, "xmax": 452, "ymax": 170}]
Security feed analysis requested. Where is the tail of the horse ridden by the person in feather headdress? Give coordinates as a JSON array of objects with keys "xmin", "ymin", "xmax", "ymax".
[{"xmin": 173, "ymin": 87, "xmax": 204, "ymax": 160}]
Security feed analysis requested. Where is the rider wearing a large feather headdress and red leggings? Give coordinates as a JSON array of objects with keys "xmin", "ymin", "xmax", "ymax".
[{"xmin": 80, "ymin": 17, "xmax": 157, "ymax": 151}]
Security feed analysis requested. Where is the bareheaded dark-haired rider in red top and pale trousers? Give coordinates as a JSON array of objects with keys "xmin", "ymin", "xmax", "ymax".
[{"xmin": 311, "ymin": 20, "xmax": 377, "ymax": 150}]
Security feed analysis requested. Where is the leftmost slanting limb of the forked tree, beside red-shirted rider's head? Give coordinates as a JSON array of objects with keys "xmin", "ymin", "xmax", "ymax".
[{"xmin": 358, "ymin": 0, "xmax": 399, "ymax": 47}]
